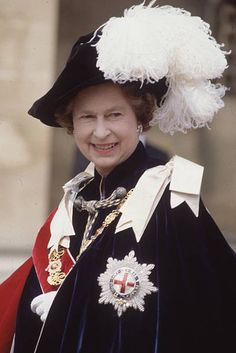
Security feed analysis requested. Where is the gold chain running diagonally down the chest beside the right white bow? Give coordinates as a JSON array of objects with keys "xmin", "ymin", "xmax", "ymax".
[{"xmin": 76, "ymin": 189, "xmax": 133, "ymax": 261}]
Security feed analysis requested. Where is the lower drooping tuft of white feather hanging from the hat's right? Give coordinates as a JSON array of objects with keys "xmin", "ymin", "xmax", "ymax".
[{"xmin": 150, "ymin": 80, "xmax": 226, "ymax": 135}]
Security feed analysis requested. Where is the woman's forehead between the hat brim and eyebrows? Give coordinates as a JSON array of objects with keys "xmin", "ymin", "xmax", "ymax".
[{"xmin": 73, "ymin": 83, "xmax": 131, "ymax": 110}]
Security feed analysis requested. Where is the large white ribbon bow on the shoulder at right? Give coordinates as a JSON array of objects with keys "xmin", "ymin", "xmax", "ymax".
[{"xmin": 115, "ymin": 156, "xmax": 203, "ymax": 242}]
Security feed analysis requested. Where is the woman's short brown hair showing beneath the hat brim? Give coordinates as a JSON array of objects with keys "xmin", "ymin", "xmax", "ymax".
[{"xmin": 55, "ymin": 83, "xmax": 157, "ymax": 134}]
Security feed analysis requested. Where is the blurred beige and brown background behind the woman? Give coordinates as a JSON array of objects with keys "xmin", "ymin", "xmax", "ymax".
[{"xmin": 0, "ymin": 0, "xmax": 236, "ymax": 282}]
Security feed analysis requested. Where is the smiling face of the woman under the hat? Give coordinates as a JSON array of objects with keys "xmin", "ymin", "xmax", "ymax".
[{"xmin": 73, "ymin": 83, "xmax": 139, "ymax": 176}]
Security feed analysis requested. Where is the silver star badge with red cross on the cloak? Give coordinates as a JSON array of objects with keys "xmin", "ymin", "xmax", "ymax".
[{"xmin": 98, "ymin": 251, "xmax": 158, "ymax": 317}]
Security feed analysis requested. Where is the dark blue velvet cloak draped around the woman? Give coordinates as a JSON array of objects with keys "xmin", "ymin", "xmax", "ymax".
[{"xmin": 14, "ymin": 144, "xmax": 236, "ymax": 353}]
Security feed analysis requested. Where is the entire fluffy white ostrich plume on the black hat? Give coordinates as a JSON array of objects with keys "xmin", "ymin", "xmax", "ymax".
[{"xmin": 96, "ymin": 1, "xmax": 227, "ymax": 134}]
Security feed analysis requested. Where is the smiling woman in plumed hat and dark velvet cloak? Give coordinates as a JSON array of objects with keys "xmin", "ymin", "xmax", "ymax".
[{"xmin": 0, "ymin": 3, "xmax": 236, "ymax": 353}]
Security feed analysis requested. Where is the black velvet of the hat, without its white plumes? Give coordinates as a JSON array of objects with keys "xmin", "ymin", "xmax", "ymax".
[{"xmin": 28, "ymin": 33, "xmax": 167, "ymax": 127}]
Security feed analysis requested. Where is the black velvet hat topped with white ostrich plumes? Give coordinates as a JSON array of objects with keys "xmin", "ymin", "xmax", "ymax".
[{"xmin": 29, "ymin": 0, "xmax": 227, "ymax": 134}]
